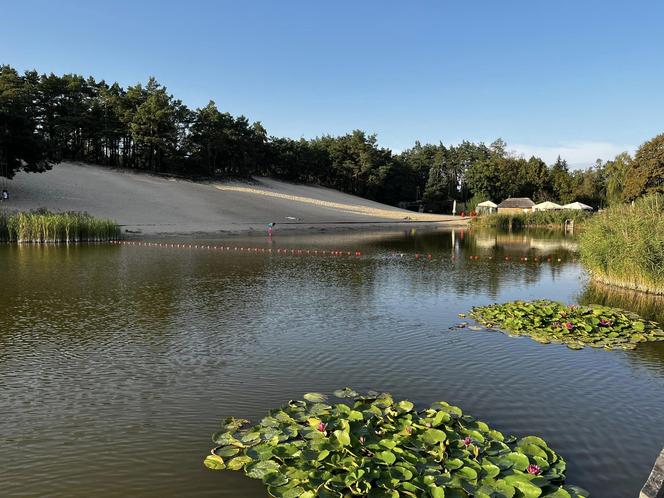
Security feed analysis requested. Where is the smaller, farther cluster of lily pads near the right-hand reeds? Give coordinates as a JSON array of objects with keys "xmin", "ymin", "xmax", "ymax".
[{"xmin": 470, "ymin": 300, "xmax": 664, "ymax": 349}]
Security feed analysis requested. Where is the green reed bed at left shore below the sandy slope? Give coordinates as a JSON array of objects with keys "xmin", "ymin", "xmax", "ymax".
[{"xmin": 0, "ymin": 209, "xmax": 120, "ymax": 244}]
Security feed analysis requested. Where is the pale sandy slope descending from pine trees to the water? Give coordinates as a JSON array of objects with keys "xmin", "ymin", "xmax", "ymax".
[{"xmin": 2, "ymin": 163, "xmax": 459, "ymax": 234}]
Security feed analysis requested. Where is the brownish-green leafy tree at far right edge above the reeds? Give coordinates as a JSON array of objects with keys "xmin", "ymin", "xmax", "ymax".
[{"xmin": 623, "ymin": 133, "xmax": 664, "ymax": 201}]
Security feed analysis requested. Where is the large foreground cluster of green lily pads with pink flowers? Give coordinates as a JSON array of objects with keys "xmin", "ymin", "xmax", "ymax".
[{"xmin": 204, "ymin": 388, "xmax": 589, "ymax": 498}]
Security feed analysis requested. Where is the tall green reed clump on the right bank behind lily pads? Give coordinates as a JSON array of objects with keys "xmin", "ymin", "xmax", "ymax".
[{"xmin": 579, "ymin": 194, "xmax": 664, "ymax": 294}]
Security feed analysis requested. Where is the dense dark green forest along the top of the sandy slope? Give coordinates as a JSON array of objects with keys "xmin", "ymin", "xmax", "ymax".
[{"xmin": 0, "ymin": 65, "xmax": 664, "ymax": 210}]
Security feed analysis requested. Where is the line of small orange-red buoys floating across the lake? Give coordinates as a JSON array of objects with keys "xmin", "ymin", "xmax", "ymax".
[{"xmin": 111, "ymin": 240, "xmax": 568, "ymax": 263}]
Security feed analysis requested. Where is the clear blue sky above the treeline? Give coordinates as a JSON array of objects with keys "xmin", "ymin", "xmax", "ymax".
[{"xmin": 0, "ymin": 0, "xmax": 664, "ymax": 166}]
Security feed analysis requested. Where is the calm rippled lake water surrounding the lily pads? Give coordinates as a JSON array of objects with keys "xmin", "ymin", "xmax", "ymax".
[{"xmin": 0, "ymin": 231, "xmax": 664, "ymax": 498}]
